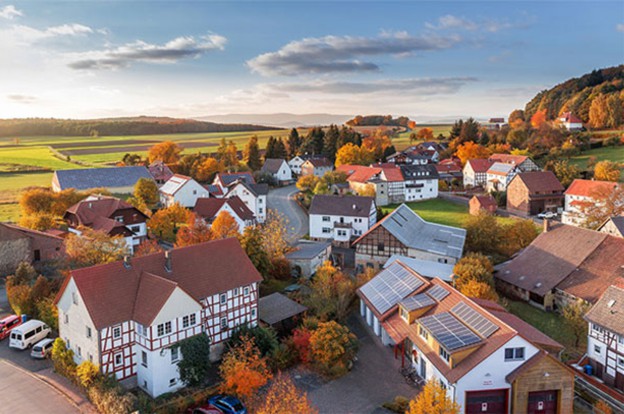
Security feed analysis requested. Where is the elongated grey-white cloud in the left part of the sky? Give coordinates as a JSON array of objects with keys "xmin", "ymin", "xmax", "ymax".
[{"xmin": 68, "ymin": 34, "xmax": 227, "ymax": 70}]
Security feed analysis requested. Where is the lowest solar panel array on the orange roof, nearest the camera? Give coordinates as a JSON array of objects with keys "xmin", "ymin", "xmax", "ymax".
[{"xmin": 418, "ymin": 312, "xmax": 481, "ymax": 352}]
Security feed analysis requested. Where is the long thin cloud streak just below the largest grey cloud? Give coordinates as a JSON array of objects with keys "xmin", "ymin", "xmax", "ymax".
[{"xmin": 267, "ymin": 77, "xmax": 477, "ymax": 95}]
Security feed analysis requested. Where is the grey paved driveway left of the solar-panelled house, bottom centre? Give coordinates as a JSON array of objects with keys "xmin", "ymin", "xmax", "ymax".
[{"xmin": 295, "ymin": 315, "xmax": 416, "ymax": 414}]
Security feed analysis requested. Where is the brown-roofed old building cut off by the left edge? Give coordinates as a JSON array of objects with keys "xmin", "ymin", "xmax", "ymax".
[{"xmin": 0, "ymin": 223, "xmax": 65, "ymax": 276}]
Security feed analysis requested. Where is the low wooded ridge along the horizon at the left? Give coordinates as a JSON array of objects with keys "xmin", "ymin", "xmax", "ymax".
[{"xmin": 0, "ymin": 116, "xmax": 275, "ymax": 137}]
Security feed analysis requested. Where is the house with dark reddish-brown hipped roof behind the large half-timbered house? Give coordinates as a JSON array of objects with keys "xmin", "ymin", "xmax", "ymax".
[{"xmin": 63, "ymin": 195, "xmax": 147, "ymax": 251}]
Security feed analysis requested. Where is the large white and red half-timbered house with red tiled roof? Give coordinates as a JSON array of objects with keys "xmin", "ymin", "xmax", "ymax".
[{"xmin": 55, "ymin": 238, "xmax": 262, "ymax": 397}]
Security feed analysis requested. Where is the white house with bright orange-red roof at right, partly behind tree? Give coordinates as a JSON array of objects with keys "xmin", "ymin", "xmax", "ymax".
[{"xmin": 561, "ymin": 178, "xmax": 618, "ymax": 226}]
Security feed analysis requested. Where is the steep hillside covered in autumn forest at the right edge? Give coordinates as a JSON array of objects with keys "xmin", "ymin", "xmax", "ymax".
[{"xmin": 525, "ymin": 65, "xmax": 624, "ymax": 127}]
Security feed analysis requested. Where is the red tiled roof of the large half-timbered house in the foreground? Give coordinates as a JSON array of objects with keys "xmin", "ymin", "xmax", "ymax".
[{"xmin": 65, "ymin": 238, "xmax": 262, "ymax": 329}]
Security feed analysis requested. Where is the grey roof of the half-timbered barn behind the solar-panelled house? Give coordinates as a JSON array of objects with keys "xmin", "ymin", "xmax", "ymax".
[{"xmin": 376, "ymin": 204, "xmax": 466, "ymax": 259}]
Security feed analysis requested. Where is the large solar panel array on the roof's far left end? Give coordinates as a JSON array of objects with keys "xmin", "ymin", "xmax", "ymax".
[{"xmin": 360, "ymin": 262, "xmax": 423, "ymax": 314}]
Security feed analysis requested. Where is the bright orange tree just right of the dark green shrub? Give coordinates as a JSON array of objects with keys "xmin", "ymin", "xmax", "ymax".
[{"xmin": 219, "ymin": 338, "xmax": 272, "ymax": 400}]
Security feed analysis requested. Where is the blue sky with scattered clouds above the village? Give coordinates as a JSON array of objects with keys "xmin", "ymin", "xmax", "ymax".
[{"xmin": 0, "ymin": 0, "xmax": 624, "ymax": 121}]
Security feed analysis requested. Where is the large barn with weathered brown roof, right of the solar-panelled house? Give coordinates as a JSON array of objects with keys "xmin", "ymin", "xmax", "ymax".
[{"xmin": 494, "ymin": 220, "xmax": 624, "ymax": 310}]
